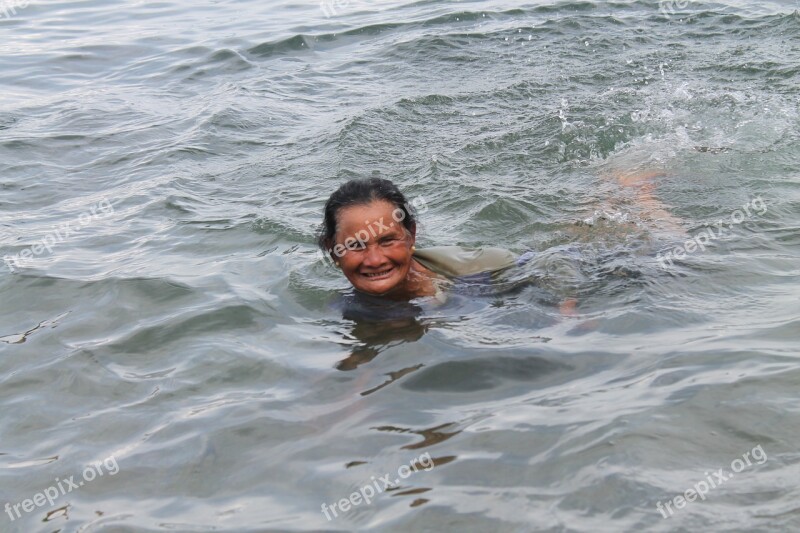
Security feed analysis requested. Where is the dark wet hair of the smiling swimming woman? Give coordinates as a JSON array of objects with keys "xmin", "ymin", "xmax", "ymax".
[{"xmin": 317, "ymin": 178, "xmax": 417, "ymax": 251}]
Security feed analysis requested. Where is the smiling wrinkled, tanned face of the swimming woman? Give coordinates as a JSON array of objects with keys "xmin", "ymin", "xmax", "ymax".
[{"xmin": 332, "ymin": 200, "xmax": 414, "ymax": 295}]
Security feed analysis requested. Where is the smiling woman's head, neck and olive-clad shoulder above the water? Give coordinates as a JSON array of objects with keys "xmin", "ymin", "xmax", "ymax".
[{"xmin": 318, "ymin": 178, "xmax": 517, "ymax": 300}]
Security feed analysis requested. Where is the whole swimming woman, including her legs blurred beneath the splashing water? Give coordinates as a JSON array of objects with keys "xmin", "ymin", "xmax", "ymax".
[{"xmin": 318, "ymin": 170, "xmax": 685, "ymax": 306}]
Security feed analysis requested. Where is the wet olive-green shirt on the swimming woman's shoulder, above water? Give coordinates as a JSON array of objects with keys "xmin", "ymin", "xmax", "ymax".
[{"xmin": 414, "ymin": 246, "xmax": 517, "ymax": 277}]
